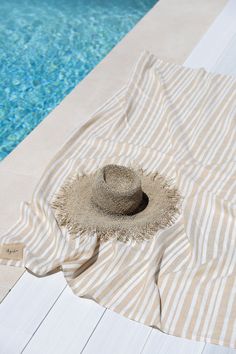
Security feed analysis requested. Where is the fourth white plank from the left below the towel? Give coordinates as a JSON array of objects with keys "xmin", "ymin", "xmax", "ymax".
[{"xmin": 141, "ymin": 329, "xmax": 205, "ymax": 354}]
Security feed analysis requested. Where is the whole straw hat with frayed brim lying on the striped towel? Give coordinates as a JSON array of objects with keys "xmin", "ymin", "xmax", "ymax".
[{"xmin": 52, "ymin": 165, "xmax": 180, "ymax": 241}]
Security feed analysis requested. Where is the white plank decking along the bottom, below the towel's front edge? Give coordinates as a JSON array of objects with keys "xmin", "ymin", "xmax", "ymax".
[{"xmin": 0, "ymin": 272, "xmax": 236, "ymax": 354}]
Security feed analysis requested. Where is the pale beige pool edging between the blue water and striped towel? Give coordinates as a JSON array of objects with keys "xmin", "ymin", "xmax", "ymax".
[{"xmin": 0, "ymin": 0, "xmax": 226, "ymax": 234}]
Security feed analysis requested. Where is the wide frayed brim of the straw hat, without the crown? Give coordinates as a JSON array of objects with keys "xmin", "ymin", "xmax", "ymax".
[{"xmin": 51, "ymin": 171, "xmax": 180, "ymax": 241}]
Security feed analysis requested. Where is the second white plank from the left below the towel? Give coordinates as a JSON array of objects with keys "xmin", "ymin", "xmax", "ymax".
[{"xmin": 23, "ymin": 287, "xmax": 105, "ymax": 354}]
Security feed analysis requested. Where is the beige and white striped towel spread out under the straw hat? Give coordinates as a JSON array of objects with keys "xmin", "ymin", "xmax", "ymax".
[{"xmin": 0, "ymin": 52, "xmax": 236, "ymax": 348}]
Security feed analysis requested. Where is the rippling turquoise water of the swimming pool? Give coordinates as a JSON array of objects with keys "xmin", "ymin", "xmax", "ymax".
[{"xmin": 0, "ymin": 0, "xmax": 157, "ymax": 159}]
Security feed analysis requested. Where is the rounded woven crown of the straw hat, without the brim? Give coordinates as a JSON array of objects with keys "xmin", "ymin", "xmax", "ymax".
[{"xmin": 92, "ymin": 165, "xmax": 143, "ymax": 215}]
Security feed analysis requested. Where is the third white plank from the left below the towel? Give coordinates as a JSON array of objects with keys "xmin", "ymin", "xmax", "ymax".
[{"xmin": 83, "ymin": 310, "xmax": 151, "ymax": 354}]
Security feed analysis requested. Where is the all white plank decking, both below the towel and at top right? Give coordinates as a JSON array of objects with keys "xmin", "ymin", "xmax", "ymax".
[{"xmin": 0, "ymin": 0, "xmax": 236, "ymax": 354}]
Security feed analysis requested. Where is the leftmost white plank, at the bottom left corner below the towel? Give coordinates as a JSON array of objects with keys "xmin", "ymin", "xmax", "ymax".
[{"xmin": 0, "ymin": 272, "xmax": 66, "ymax": 354}]
